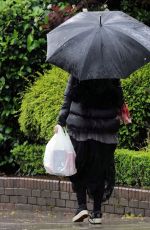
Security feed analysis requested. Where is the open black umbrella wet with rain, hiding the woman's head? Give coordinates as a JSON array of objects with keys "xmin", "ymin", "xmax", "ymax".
[{"xmin": 47, "ymin": 11, "xmax": 150, "ymax": 80}]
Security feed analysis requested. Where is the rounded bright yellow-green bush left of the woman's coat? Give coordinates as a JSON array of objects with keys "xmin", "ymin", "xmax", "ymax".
[{"xmin": 19, "ymin": 67, "xmax": 68, "ymax": 142}]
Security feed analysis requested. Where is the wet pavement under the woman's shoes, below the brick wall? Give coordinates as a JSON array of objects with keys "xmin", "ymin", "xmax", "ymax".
[{"xmin": 0, "ymin": 210, "xmax": 150, "ymax": 230}]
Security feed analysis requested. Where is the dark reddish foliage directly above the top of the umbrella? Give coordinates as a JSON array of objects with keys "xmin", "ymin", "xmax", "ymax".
[{"xmin": 43, "ymin": 0, "xmax": 150, "ymax": 30}]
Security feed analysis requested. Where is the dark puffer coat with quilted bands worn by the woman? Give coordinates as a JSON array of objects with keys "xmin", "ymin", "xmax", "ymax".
[{"xmin": 58, "ymin": 76, "xmax": 123, "ymax": 133}]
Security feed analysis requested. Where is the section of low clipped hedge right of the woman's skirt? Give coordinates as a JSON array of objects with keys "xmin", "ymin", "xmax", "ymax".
[{"xmin": 115, "ymin": 149, "xmax": 150, "ymax": 187}]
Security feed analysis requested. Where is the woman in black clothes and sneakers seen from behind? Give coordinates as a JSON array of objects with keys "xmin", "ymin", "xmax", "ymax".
[{"xmin": 55, "ymin": 76, "xmax": 124, "ymax": 224}]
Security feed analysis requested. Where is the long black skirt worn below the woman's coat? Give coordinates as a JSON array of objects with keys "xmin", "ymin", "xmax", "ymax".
[{"xmin": 70, "ymin": 137, "xmax": 116, "ymax": 202}]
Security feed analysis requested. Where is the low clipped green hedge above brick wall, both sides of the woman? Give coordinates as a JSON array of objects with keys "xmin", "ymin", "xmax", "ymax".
[{"xmin": 12, "ymin": 144, "xmax": 150, "ymax": 187}]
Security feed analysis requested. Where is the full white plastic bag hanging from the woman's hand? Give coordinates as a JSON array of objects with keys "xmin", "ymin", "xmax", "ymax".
[{"xmin": 43, "ymin": 125, "xmax": 77, "ymax": 176}]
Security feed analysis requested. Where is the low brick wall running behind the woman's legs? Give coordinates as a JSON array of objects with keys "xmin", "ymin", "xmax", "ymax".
[{"xmin": 0, "ymin": 177, "xmax": 150, "ymax": 216}]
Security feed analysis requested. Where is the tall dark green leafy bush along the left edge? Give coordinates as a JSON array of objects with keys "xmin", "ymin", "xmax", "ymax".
[{"xmin": 0, "ymin": 0, "xmax": 49, "ymax": 161}]
